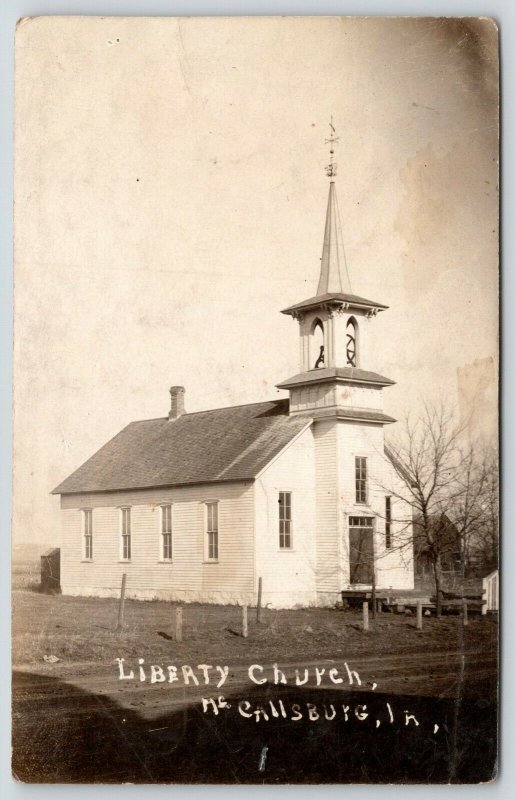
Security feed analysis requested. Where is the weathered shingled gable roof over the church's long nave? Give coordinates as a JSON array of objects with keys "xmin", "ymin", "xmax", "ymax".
[{"xmin": 52, "ymin": 400, "xmax": 312, "ymax": 494}]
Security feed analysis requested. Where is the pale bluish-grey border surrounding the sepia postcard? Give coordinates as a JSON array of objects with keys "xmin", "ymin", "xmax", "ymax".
[{"xmin": 0, "ymin": 0, "xmax": 515, "ymax": 800}]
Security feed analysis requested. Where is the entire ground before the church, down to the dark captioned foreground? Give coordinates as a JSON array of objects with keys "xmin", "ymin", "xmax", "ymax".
[{"xmin": 13, "ymin": 588, "xmax": 497, "ymax": 783}]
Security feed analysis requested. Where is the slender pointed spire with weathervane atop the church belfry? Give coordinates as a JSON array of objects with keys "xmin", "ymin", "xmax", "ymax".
[{"xmin": 317, "ymin": 122, "xmax": 352, "ymax": 296}]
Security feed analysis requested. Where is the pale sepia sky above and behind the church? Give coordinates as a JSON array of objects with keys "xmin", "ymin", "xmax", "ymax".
[{"xmin": 13, "ymin": 17, "xmax": 498, "ymax": 544}]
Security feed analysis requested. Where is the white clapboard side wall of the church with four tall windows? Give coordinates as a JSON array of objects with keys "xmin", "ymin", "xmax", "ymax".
[{"xmin": 61, "ymin": 482, "xmax": 254, "ymax": 602}]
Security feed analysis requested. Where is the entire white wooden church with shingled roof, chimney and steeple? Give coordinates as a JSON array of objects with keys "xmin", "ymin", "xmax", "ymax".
[{"xmin": 53, "ymin": 144, "xmax": 413, "ymax": 608}]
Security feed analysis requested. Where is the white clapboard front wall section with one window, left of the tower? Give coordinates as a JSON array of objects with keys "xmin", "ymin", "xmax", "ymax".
[{"xmin": 255, "ymin": 428, "xmax": 316, "ymax": 608}]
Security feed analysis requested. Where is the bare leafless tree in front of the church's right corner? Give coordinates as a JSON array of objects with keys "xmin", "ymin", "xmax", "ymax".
[{"xmin": 387, "ymin": 404, "xmax": 497, "ymax": 616}]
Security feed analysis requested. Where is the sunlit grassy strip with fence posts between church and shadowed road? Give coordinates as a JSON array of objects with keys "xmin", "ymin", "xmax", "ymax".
[{"xmin": 13, "ymin": 590, "xmax": 497, "ymax": 676}]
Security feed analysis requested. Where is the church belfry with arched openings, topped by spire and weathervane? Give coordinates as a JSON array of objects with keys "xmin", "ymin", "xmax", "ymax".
[{"xmin": 278, "ymin": 120, "xmax": 395, "ymax": 424}]
